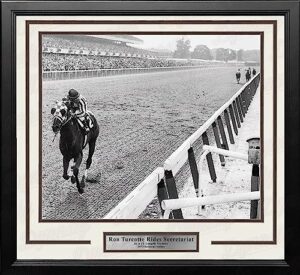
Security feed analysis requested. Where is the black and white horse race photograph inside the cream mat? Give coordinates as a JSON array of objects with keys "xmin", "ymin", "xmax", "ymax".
[{"xmin": 39, "ymin": 32, "xmax": 263, "ymax": 221}]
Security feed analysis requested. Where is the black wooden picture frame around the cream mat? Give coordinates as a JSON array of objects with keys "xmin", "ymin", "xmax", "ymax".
[{"xmin": 1, "ymin": 0, "xmax": 300, "ymax": 274}]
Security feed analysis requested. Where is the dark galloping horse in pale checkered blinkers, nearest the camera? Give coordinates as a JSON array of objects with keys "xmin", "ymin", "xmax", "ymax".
[{"xmin": 51, "ymin": 101, "xmax": 99, "ymax": 194}]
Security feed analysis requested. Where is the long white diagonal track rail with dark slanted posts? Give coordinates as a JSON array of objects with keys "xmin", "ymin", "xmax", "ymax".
[{"xmin": 104, "ymin": 74, "xmax": 260, "ymax": 219}]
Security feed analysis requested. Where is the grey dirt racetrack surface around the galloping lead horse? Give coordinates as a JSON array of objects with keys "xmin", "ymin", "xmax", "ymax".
[{"xmin": 42, "ymin": 67, "xmax": 251, "ymax": 220}]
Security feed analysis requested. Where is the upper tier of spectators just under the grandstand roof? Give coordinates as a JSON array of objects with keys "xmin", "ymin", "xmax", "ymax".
[{"xmin": 43, "ymin": 35, "xmax": 156, "ymax": 56}]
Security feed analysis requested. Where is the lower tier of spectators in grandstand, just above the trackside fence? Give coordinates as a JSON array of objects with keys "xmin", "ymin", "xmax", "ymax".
[{"xmin": 42, "ymin": 53, "xmax": 191, "ymax": 71}]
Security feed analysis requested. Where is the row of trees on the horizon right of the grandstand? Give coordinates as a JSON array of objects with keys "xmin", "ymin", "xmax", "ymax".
[{"xmin": 173, "ymin": 38, "xmax": 260, "ymax": 62}]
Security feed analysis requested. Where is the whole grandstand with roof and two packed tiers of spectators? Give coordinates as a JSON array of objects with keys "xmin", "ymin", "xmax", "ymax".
[{"xmin": 42, "ymin": 34, "xmax": 196, "ymax": 71}]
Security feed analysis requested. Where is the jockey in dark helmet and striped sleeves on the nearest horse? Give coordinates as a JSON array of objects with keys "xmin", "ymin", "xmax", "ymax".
[{"xmin": 67, "ymin": 89, "xmax": 90, "ymax": 133}]
